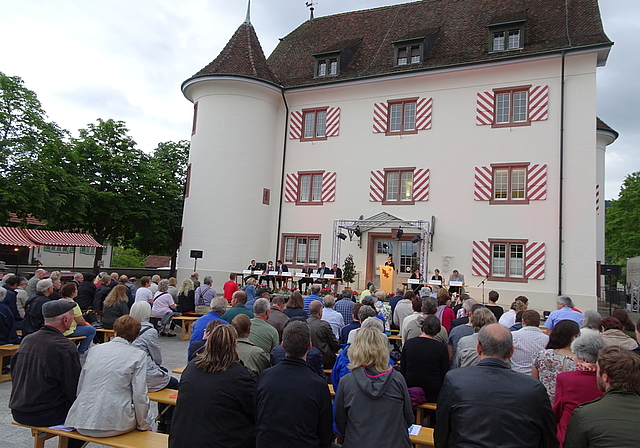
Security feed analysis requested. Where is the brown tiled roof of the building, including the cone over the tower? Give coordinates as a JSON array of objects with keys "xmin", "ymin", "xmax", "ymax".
[{"xmin": 188, "ymin": 0, "xmax": 611, "ymax": 87}]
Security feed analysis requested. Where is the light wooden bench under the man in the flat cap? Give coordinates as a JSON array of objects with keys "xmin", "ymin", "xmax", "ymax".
[{"xmin": 13, "ymin": 422, "xmax": 169, "ymax": 448}]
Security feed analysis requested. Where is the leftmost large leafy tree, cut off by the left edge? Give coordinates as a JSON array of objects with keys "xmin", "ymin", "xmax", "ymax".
[{"xmin": 0, "ymin": 72, "xmax": 80, "ymax": 222}]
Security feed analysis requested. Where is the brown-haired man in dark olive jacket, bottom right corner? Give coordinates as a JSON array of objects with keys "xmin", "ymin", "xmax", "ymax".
[{"xmin": 564, "ymin": 345, "xmax": 640, "ymax": 448}]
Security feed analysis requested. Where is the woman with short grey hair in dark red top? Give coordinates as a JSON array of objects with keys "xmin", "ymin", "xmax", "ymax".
[{"xmin": 553, "ymin": 332, "xmax": 605, "ymax": 446}]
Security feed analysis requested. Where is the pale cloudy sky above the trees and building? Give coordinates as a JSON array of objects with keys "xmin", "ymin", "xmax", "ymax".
[{"xmin": 0, "ymin": 0, "xmax": 640, "ymax": 199}]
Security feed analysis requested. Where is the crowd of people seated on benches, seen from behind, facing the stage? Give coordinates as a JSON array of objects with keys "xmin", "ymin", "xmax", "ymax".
[{"xmin": 7, "ymin": 270, "xmax": 640, "ymax": 448}]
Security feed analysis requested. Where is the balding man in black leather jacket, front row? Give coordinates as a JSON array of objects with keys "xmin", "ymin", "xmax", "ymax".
[{"xmin": 434, "ymin": 324, "xmax": 558, "ymax": 448}]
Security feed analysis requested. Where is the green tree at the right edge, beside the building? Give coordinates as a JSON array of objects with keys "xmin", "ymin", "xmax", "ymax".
[{"xmin": 605, "ymin": 172, "xmax": 640, "ymax": 265}]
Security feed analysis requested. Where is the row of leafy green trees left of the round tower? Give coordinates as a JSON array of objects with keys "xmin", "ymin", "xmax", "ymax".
[{"xmin": 0, "ymin": 72, "xmax": 189, "ymax": 272}]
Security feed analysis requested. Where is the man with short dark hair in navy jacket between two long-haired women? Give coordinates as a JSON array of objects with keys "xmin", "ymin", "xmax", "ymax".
[{"xmin": 256, "ymin": 321, "xmax": 333, "ymax": 448}]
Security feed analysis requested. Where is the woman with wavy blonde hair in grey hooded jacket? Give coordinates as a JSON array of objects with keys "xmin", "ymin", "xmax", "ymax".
[{"xmin": 335, "ymin": 328, "xmax": 413, "ymax": 448}]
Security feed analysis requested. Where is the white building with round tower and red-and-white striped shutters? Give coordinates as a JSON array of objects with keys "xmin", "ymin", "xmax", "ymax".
[{"xmin": 178, "ymin": 0, "xmax": 617, "ymax": 309}]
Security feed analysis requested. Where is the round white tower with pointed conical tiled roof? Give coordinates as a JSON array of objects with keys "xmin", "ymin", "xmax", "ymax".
[{"xmin": 178, "ymin": 17, "xmax": 285, "ymax": 290}]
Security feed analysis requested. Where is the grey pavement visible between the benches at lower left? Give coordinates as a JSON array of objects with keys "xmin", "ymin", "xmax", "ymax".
[{"xmin": 0, "ymin": 328, "xmax": 189, "ymax": 448}]
